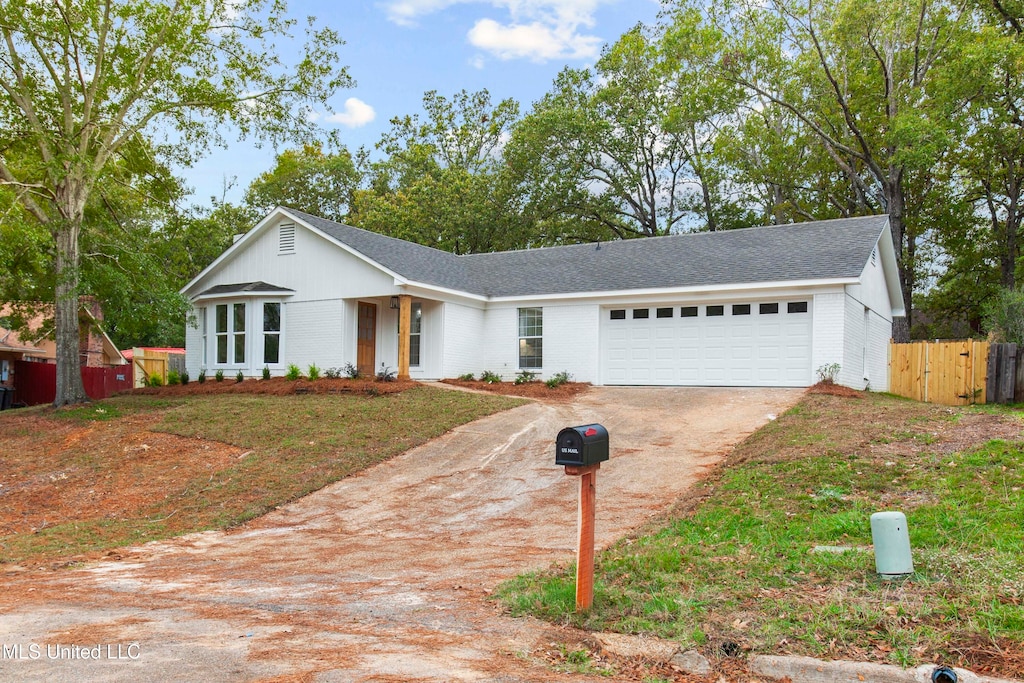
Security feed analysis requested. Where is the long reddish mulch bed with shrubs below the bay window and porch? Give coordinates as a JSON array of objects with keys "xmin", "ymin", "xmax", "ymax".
[{"xmin": 132, "ymin": 377, "xmax": 417, "ymax": 396}]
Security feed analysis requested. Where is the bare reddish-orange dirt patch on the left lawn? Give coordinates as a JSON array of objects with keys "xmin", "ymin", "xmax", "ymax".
[{"xmin": 0, "ymin": 412, "xmax": 242, "ymax": 565}]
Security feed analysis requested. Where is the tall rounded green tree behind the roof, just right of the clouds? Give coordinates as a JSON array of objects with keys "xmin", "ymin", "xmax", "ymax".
[{"xmin": 506, "ymin": 27, "xmax": 693, "ymax": 242}]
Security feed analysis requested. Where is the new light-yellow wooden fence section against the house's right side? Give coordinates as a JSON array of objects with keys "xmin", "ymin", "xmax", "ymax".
[{"xmin": 889, "ymin": 340, "xmax": 989, "ymax": 405}]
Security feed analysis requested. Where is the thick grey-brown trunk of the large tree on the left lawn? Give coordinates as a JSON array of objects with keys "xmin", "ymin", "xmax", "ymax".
[{"xmin": 53, "ymin": 213, "xmax": 89, "ymax": 407}]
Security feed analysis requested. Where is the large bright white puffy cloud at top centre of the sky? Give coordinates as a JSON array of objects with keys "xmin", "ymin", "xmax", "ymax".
[{"xmin": 467, "ymin": 19, "xmax": 601, "ymax": 61}]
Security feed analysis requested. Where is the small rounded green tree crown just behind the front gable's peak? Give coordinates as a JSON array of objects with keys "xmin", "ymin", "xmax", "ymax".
[{"xmin": 245, "ymin": 142, "xmax": 360, "ymax": 221}]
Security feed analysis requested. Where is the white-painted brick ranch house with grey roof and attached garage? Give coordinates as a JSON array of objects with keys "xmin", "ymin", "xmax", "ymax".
[{"xmin": 181, "ymin": 208, "xmax": 904, "ymax": 390}]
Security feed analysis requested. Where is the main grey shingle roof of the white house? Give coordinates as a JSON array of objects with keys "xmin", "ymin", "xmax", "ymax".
[{"xmin": 288, "ymin": 209, "xmax": 888, "ymax": 297}]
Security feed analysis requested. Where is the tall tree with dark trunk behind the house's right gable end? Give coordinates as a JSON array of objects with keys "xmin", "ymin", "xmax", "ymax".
[{"xmin": 679, "ymin": 0, "xmax": 966, "ymax": 341}]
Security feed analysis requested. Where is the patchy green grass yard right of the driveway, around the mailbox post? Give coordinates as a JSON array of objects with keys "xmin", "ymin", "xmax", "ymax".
[{"xmin": 498, "ymin": 393, "xmax": 1024, "ymax": 678}]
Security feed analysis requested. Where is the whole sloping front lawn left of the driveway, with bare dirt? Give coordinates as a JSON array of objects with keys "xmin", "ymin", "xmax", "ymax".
[{"xmin": 0, "ymin": 386, "xmax": 522, "ymax": 566}]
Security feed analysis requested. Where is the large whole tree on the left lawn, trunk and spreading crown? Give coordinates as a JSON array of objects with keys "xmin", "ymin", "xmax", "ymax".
[{"xmin": 0, "ymin": 0, "xmax": 349, "ymax": 405}]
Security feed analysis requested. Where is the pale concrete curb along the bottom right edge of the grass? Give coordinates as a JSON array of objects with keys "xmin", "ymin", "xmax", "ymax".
[{"xmin": 748, "ymin": 654, "xmax": 1016, "ymax": 683}]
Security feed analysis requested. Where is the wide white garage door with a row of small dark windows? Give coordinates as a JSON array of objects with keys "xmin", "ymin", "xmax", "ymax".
[{"xmin": 601, "ymin": 299, "xmax": 811, "ymax": 386}]
